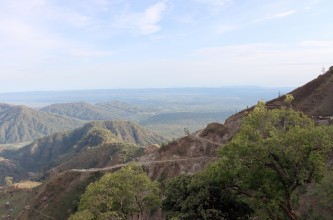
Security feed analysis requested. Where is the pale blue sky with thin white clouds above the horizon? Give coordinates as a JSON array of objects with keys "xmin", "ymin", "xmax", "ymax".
[{"xmin": 0, "ymin": 0, "xmax": 333, "ymax": 92}]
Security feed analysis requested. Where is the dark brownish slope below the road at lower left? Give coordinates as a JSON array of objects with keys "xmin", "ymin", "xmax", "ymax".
[{"xmin": 16, "ymin": 172, "xmax": 102, "ymax": 220}]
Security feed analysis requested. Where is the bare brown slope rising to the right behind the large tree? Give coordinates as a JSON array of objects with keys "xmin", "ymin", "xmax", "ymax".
[{"xmin": 144, "ymin": 67, "xmax": 333, "ymax": 178}]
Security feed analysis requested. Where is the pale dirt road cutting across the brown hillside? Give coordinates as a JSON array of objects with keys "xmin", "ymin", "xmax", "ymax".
[{"xmin": 69, "ymin": 156, "xmax": 217, "ymax": 172}]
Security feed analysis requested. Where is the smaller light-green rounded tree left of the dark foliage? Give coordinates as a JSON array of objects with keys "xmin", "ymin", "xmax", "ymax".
[{"xmin": 71, "ymin": 164, "xmax": 160, "ymax": 220}]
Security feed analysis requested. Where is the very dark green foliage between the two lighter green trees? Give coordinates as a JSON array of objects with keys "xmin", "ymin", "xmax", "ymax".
[{"xmin": 162, "ymin": 174, "xmax": 252, "ymax": 219}]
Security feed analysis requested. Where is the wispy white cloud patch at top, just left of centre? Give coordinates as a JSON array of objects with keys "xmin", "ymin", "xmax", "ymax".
[{"xmin": 116, "ymin": 1, "xmax": 166, "ymax": 35}]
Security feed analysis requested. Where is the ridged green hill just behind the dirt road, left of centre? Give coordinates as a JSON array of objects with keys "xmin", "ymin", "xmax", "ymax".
[{"xmin": 8, "ymin": 121, "xmax": 164, "ymax": 174}]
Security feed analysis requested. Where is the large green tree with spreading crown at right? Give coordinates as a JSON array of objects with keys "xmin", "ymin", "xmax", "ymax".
[{"xmin": 207, "ymin": 102, "xmax": 333, "ymax": 219}]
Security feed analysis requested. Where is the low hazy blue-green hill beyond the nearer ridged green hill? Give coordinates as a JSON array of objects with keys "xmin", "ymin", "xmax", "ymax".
[{"xmin": 40, "ymin": 101, "xmax": 149, "ymax": 120}]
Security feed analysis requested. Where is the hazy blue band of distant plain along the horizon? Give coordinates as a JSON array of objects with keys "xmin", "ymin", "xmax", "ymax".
[{"xmin": 0, "ymin": 86, "xmax": 292, "ymax": 108}]
